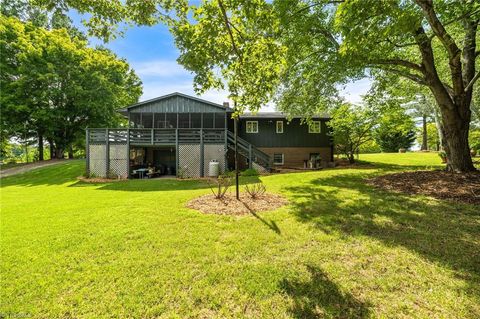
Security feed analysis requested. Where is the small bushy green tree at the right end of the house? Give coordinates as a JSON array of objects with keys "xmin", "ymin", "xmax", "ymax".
[{"xmin": 328, "ymin": 103, "xmax": 376, "ymax": 163}]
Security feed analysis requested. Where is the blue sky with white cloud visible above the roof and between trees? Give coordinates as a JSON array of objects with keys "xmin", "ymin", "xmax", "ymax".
[{"xmin": 70, "ymin": 12, "xmax": 370, "ymax": 111}]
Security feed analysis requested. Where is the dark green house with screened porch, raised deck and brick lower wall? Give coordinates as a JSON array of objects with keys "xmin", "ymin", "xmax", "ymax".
[{"xmin": 86, "ymin": 93, "xmax": 333, "ymax": 178}]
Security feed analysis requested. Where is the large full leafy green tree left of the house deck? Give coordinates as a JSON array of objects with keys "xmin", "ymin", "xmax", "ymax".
[{"xmin": 0, "ymin": 16, "xmax": 141, "ymax": 158}]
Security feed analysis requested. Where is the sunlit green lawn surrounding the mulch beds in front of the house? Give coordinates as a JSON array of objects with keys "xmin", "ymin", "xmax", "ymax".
[{"xmin": 0, "ymin": 153, "xmax": 480, "ymax": 318}]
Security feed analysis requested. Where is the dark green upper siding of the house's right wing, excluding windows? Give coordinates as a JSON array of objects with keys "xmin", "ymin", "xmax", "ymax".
[{"xmin": 234, "ymin": 118, "xmax": 331, "ymax": 147}]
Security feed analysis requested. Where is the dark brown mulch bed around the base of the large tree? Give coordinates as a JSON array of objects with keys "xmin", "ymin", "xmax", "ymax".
[{"xmin": 367, "ymin": 171, "xmax": 480, "ymax": 205}]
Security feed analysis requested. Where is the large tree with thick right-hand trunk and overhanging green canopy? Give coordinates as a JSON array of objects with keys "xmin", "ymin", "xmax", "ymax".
[{"xmin": 31, "ymin": 0, "xmax": 480, "ymax": 172}]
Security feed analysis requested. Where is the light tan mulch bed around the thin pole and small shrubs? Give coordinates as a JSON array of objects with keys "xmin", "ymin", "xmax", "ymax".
[{"xmin": 186, "ymin": 193, "xmax": 288, "ymax": 215}]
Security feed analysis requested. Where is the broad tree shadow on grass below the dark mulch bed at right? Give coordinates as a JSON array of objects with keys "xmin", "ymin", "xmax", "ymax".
[{"xmin": 285, "ymin": 173, "xmax": 480, "ymax": 295}]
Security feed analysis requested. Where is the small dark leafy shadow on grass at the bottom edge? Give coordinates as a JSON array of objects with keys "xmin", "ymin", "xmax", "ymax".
[{"xmin": 280, "ymin": 265, "xmax": 370, "ymax": 318}]
